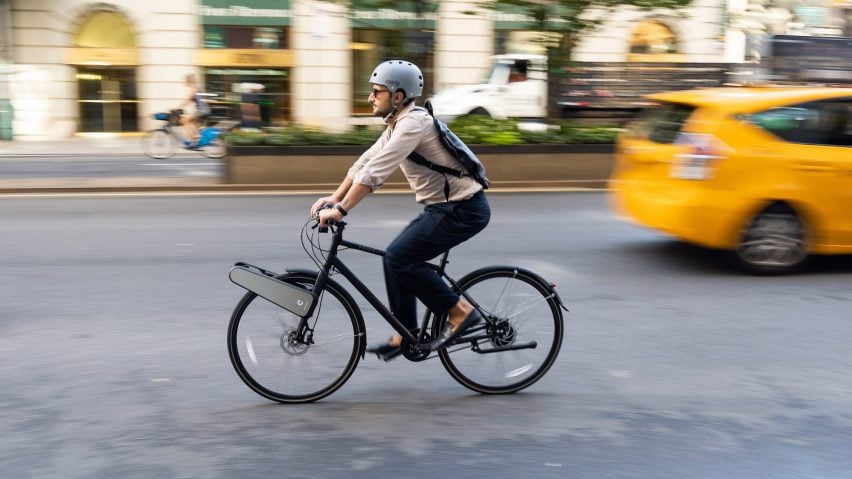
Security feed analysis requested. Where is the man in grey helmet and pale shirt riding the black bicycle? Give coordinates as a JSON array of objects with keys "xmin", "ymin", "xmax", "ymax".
[{"xmin": 311, "ymin": 60, "xmax": 491, "ymax": 358}]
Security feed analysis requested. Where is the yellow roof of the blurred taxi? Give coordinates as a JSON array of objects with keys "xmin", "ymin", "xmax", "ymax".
[{"xmin": 645, "ymin": 86, "xmax": 852, "ymax": 111}]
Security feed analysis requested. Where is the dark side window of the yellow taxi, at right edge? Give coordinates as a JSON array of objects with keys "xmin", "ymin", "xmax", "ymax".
[{"xmin": 749, "ymin": 99, "xmax": 852, "ymax": 146}]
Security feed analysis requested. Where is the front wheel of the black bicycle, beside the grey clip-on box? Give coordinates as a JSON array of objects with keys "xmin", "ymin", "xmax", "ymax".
[{"xmin": 228, "ymin": 273, "xmax": 366, "ymax": 404}]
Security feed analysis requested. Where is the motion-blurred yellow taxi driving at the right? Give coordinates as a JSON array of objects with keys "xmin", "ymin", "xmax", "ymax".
[{"xmin": 610, "ymin": 86, "xmax": 852, "ymax": 274}]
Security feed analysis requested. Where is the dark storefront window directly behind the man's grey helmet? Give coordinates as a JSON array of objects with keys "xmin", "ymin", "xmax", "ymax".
[{"xmin": 352, "ymin": 29, "xmax": 435, "ymax": 115}]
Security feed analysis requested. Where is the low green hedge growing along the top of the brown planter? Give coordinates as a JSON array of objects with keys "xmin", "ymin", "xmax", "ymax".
[{"xmin": 226, "ymin": 116, "xmax": 621, "ymax": 146}]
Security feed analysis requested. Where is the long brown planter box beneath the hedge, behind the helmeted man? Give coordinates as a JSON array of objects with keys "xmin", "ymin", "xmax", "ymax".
[{"xmin": 225, "ymin": 145, "xmax": 614, "ymax": 190}]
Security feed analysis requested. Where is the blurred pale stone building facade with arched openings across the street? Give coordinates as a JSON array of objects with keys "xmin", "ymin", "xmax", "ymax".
[{"xmin": 0, "ymin": 0, "xmax": 848, "ymax": 140}]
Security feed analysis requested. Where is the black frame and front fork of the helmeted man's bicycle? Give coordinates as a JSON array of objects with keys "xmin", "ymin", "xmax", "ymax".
[{"xmin": 298, "ymin": 221, "xmax": 484, "ymax": 350}]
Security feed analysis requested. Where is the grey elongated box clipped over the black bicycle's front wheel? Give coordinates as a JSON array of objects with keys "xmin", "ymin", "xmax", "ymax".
[{"xmin": 228, "ymin": 263, "xmax": 316, "ymax": 317}]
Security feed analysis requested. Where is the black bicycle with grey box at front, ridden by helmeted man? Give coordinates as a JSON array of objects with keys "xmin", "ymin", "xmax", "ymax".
[{"xmin": 228, "ymin": 218, "xmax": 567, "ymax": 403}]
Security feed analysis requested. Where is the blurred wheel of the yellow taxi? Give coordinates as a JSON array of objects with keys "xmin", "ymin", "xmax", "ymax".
[{"xmin": 734, "ymin": 204, "xmax": 809, "ymax": 274}]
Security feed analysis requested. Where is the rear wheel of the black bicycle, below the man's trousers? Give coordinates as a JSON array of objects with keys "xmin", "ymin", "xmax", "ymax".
[{"xmin": 433, "ymin": 266, "xmax": 564, "ymax": 394}]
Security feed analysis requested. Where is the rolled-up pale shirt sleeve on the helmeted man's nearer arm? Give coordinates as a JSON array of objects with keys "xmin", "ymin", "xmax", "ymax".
[{"xmin": 348, "ymin": 117, "xmax": 423, "ymax": 191}]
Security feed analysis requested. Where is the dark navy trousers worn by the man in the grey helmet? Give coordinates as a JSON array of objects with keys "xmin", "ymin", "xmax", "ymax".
[{"xmin": 384, "ymin": 191, "xmax": 491, "ymax": 330}]
